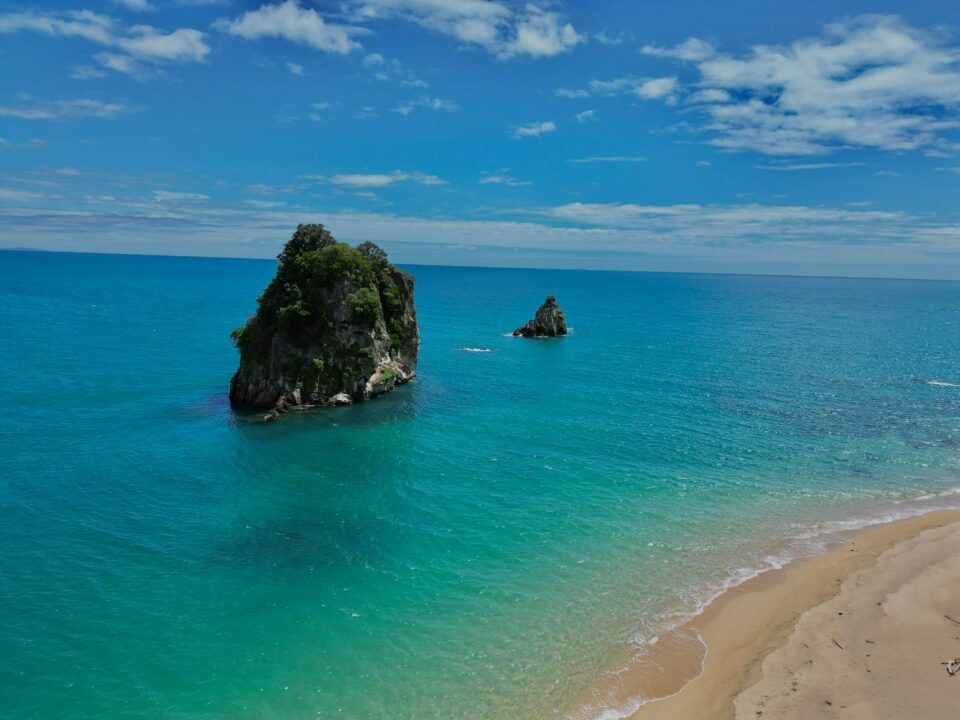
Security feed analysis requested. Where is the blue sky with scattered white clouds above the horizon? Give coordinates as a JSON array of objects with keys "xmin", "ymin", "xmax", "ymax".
[{"xmin": 0, "ymin": 0, "xmax": 960, "ymax": 279}]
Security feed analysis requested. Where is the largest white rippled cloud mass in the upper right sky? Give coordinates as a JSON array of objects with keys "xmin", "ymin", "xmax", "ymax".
[{"xmin": 660, "ymin": 15, "xmax": 960, "ymax": 156}]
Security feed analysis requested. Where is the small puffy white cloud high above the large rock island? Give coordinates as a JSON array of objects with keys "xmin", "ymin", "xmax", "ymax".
[{"xmin": 216, "ymin": 0, "xmax": 366, "ymax": 55}]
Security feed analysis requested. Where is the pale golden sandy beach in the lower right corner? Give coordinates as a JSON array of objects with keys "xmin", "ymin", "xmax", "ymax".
[{"xmin": 580, "ymin": 511, "xmax": 960, "ymax": 720}]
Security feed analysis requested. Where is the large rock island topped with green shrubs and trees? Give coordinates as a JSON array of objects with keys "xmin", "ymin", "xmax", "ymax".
[{"xmin": 230, "ymin": 225, "xmax": 420, "ymax": 419}]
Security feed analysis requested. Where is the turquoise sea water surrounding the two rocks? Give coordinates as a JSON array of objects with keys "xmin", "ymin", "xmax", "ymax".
[{"xmin": 0, "ymin": 252, "xmax": 960, "ymax": 720}]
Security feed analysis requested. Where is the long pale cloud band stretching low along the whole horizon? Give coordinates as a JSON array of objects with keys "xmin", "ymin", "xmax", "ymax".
[{"xmin": 0, "ymin": 198, "xmax": 960, "ymax": 278}]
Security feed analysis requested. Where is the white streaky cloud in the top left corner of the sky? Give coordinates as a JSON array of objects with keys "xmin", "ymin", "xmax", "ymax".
[{"xmin": 0, "ymin": 10, "xmax": 210, "ymax": 79}]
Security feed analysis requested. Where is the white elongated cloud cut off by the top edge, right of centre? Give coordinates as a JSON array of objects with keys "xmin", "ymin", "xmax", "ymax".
[{"xmin": 351, "ymin": 0, "xmax": 583, "ymax": 58}]
